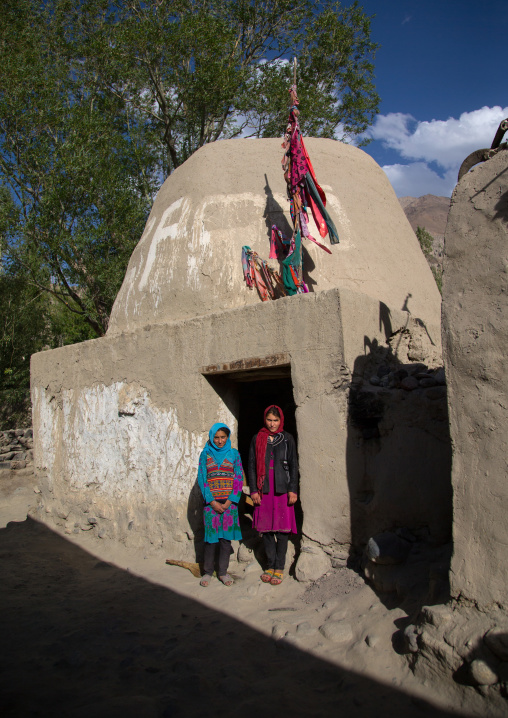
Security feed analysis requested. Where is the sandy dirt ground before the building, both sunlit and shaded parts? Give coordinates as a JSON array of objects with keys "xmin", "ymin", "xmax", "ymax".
[{"xmin": 0, "ymin": 472, "xmax": 481, "ymax": 718}]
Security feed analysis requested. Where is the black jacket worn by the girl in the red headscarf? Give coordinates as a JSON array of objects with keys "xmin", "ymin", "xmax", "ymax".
[{"xmin": 247, "ymin": 431, "xmax": 298, "ymax": 494}]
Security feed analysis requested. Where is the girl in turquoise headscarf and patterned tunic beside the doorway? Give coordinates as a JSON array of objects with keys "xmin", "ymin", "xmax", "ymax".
[{"xmin": 198, "ymin": 423, "xmax": 243, "ymax": 586}]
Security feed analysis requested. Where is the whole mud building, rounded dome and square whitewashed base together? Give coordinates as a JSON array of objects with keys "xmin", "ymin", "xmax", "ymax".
[{"xmin": 32, "ymin": 140, "xmax": 448, "ymax": 570}]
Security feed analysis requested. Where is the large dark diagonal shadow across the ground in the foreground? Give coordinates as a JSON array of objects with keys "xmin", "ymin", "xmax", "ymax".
[{"xmin": 0, "ymin": 520, "xmax": 460, "ymax": 718}]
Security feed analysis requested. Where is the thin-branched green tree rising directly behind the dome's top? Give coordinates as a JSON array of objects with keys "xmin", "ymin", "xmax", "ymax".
[{"xmin": 73, "ymin": 0, "xmax": 379, "ymax": 176}]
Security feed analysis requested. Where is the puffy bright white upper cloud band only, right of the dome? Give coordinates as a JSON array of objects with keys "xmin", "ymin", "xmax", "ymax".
[{"xmin": 368, "ymin": 107, "xmax": 508, "ymax": 169}]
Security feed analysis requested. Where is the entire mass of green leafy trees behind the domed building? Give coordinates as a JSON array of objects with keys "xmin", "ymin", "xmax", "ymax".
[{"xmin": 0, "ymin": 0, "xmax": 379, "ymax": 344}]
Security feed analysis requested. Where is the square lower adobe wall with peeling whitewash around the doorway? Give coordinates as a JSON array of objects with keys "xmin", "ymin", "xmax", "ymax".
[{"xmin": 32, "ymin": 289, "xmax": 447, "ymax": 560}]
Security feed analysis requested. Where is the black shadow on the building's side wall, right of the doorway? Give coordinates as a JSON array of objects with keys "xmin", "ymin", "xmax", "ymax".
[{"xmin": 346, "ymin": 295, "xmax": 452, "ymax": 603}]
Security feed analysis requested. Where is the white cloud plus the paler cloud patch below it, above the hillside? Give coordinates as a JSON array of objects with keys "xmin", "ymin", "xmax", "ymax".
[{"xmin": 367, "ymin": 107, "xmax": 508, "ymax": 197}]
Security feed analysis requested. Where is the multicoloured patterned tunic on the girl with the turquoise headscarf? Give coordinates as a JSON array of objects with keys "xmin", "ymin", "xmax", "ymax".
[{"xmin": 198, "ymin": 449, "xmax": 243, "ymax": 543}]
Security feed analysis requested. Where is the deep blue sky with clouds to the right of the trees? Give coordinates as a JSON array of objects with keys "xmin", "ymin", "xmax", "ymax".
[{"xmin": 360, "ymin": 0, "xmax": 508, "ymax": 197}]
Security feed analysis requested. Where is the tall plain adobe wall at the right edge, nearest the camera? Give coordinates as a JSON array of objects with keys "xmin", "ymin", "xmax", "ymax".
[{"xmin": 443, "ymin": 151, "xmax": 508, "ymax": 607}]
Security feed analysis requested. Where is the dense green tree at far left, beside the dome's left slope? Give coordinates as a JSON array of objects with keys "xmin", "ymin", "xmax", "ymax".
[{"xmin": 0, "ymin": 0, "xmax": 156, "ymax": 336}]
